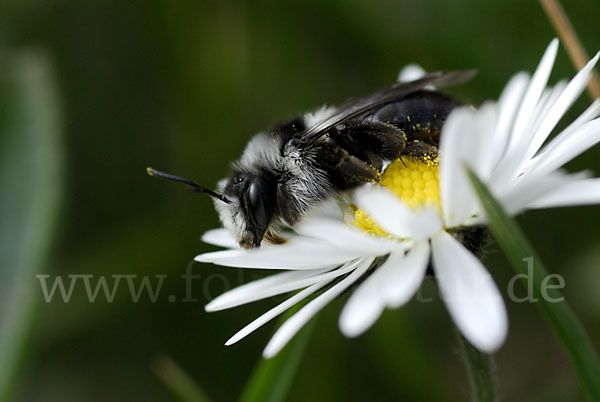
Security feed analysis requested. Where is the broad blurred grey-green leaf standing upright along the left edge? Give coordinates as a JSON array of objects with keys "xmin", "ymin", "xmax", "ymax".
[{"xmin": 0, "ymin": 51, "xmax": 62, "ymax": 400}]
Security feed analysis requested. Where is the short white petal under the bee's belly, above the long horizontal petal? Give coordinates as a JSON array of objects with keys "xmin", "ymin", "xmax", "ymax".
[{"xmin": 295, "ymin": 218, "xmax": 398, "ymax": 256}]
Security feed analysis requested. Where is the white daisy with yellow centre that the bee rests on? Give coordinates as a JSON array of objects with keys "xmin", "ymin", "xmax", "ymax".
[{"xmin": 196, "ymin": 40, "xmax": 600, "ymax": 357}]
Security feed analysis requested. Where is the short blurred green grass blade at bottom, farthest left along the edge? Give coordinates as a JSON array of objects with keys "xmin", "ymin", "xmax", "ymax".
[{"xmin": 153, "ymin": 356, "xmax": 210, "ymax": 402}]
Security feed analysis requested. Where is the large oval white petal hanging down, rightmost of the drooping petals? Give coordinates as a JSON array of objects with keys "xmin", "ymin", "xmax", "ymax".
[{"xmin": 432, "ymin": 233, "xmax": 508, "ymax": 353}]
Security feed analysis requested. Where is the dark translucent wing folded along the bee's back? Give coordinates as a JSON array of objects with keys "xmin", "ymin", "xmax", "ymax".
[{"xmin": 298, "ymin": 70, "xmax": 477, "ymax": 143}]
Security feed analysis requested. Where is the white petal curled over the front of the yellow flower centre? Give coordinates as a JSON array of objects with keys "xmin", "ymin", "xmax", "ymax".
[{"xmin": 355, "ymin": 187, "xmax": 442, "ymax": 240}]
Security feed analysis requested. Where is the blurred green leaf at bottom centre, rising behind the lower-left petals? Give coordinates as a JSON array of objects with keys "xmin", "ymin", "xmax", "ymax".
[{"xmin": 240, "ymin": 308, "xmax": 316, "ymax": 402}]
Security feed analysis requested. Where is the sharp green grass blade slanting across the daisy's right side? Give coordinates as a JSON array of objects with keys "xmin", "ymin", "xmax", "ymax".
[{"xmin": 469, "ymin": 171, "xmax": 600, "ymax": 401}]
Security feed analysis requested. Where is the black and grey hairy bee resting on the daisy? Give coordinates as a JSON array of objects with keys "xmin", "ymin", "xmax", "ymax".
[{"xmin": 148, "ymin": 70, "xmax": 474, "ymax": 248}]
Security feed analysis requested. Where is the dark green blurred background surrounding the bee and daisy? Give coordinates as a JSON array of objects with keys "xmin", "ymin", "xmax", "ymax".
[{"xmin": 0, "ymin": 0, "xmax": 600, "ymax": 401}]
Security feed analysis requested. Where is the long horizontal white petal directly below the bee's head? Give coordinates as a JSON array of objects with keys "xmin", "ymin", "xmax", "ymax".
[{"xmin": 195, "ymin": 237, "xmax": 362, "ymax": 269}]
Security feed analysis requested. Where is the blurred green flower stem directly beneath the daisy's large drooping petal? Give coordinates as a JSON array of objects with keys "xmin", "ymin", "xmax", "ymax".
[{"xmin": 458, "ymin": 334, "xmax": 498, "ymax": 402}]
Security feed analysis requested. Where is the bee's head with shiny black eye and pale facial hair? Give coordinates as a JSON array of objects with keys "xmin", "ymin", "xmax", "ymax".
[{"xmin": 214, "ymin": 173, "xmax": 276, "ymax": 248}]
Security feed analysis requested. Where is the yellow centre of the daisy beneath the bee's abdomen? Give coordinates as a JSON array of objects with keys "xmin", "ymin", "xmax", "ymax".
[{"xmin": 353, "ymin": 156, "xmax": 441, "ymax": 236}]
